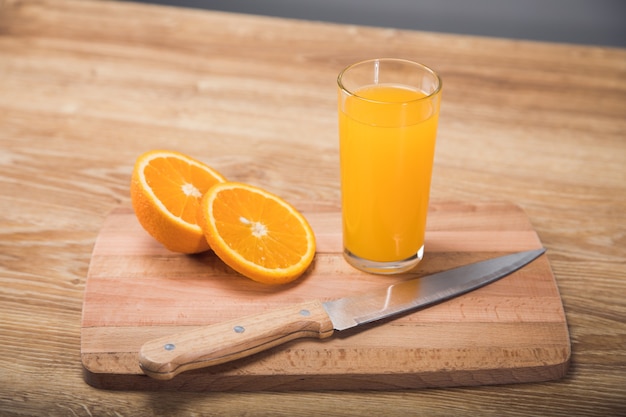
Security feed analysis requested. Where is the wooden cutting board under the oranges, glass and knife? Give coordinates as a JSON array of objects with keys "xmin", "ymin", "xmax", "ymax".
[{"xmin": 81, "ymin": 202, "xmax": 570, "ymax": 391}]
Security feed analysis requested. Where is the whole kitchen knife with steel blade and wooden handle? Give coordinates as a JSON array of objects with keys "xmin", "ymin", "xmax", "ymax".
[{"xmin": 139, "ymin": 248, "xmax": 545, "ymax": 380}]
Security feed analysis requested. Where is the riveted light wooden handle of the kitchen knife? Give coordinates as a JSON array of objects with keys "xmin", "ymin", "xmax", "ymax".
[{"xmin": 139, "ymin": 301, "xmax": 334, "ymax": 380}]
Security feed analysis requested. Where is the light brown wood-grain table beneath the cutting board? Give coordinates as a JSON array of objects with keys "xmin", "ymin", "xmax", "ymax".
[{"xmin": 0, "ymin": 0, "xmax": 626, "ymax": 416}]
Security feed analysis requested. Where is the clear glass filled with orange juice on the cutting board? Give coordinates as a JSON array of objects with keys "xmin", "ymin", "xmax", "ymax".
[{"xmin": 337, "ymin": 58, "xmax": 442, "ymax": 274}]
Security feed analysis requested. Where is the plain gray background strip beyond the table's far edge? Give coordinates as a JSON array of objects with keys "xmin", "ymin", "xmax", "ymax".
[{"xmin": 124, "ymin": 0, "xmax": 626, "ymax": 47}]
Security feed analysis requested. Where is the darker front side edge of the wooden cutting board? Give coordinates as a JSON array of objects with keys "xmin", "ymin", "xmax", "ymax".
[{"xmin": 83, "ymin": 356, "xmax": 571, "ymax": 392}]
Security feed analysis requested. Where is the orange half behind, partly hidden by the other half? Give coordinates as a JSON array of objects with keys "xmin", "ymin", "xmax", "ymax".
[{"xmin": 130, "ymin": 150, "xmax": 226, "ymax": 253}]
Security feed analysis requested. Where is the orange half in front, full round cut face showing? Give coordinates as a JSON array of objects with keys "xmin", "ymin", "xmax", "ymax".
[{"xmin": 198, "ymin": 182, "xmax": 315, "ymax": 284}]
